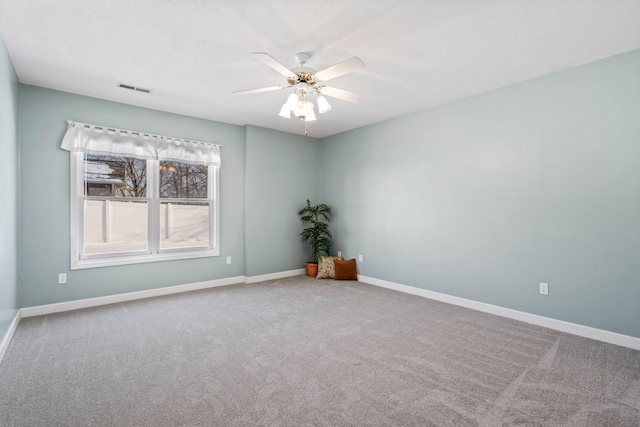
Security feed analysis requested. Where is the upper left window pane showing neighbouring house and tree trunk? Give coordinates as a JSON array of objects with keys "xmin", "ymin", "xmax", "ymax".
[{"xmin": 84, "ymin": 154, "xmax": 147, "ymax": 197}]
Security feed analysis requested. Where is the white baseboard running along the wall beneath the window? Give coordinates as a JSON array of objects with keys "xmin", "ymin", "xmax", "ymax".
[{"xmin": 20, "ymin": 276, "xmax": 243, "ymax": 317}]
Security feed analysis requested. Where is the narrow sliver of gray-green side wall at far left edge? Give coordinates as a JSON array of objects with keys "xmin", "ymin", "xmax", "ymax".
[{"xmin": 0, "ymin": 37, "xmax": 19, "ymax": 341}]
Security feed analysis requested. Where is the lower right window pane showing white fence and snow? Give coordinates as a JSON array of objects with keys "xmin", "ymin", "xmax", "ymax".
[{"xmin": 160, "ymin": 202, "xmax": 209, "ymax": 249}]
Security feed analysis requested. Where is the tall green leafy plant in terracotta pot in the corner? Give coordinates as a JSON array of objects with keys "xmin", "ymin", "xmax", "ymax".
[{"xmin": 298, "ymin": 199, "xmax": 332, "ymax": 277}]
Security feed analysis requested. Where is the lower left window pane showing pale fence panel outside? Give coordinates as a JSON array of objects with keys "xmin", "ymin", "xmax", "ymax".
[{"xmin": 84, "ymin": 200, "xmax": 148, "ymax": 255}]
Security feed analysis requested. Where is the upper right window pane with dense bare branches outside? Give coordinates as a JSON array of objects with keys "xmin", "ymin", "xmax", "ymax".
[{"xmin": 160, "ymin": 161, "xmax": 208, "ymax": 199}]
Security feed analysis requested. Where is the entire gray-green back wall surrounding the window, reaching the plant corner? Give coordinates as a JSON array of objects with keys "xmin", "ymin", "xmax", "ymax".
[{"xmin": 20, "ymin": 85, "xmax": 318, "ymax": 307}]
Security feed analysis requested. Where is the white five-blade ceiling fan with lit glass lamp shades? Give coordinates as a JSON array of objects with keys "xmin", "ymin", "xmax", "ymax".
[{"xmin": 233, "ymin": 52, "xmax": 365, "ymax": 122}]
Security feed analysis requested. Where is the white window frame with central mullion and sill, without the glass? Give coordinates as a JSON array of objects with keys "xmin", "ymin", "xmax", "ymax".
[{"xmin": 69, "ymin": 151, "xmax": 220, "ymax": 270}]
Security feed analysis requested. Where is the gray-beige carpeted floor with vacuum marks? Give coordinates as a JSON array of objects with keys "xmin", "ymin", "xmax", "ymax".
[{"xmin": 0, "ymin": 276, "xmax": 640, "ymax": 426}]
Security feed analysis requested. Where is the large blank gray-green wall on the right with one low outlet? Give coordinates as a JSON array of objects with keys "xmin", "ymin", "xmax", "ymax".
[{"xmin": 320, "ymin": 51, "xmax": 640, "ymax": 337}]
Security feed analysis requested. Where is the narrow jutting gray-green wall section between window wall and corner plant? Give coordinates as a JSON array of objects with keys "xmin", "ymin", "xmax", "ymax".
[{"xmin": 244, "ymin": 124, "xmax": 319, "ymax": 277}]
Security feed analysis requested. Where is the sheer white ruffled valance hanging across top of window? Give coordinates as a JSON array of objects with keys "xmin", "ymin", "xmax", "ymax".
[{"xmin": 60, "ymin": 120, "xmax": 220, "ymax": 166}]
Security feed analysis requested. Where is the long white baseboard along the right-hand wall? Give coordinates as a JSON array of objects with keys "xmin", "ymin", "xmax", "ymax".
[{"xmin": 358, "ymin": 275, "xmax": 640, "ymax": 350}]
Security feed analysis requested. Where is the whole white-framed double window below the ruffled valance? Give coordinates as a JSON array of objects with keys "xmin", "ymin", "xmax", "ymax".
[{"xmin": 63, "ymin": 122, "xmax": 219, "ymax": 269}]
